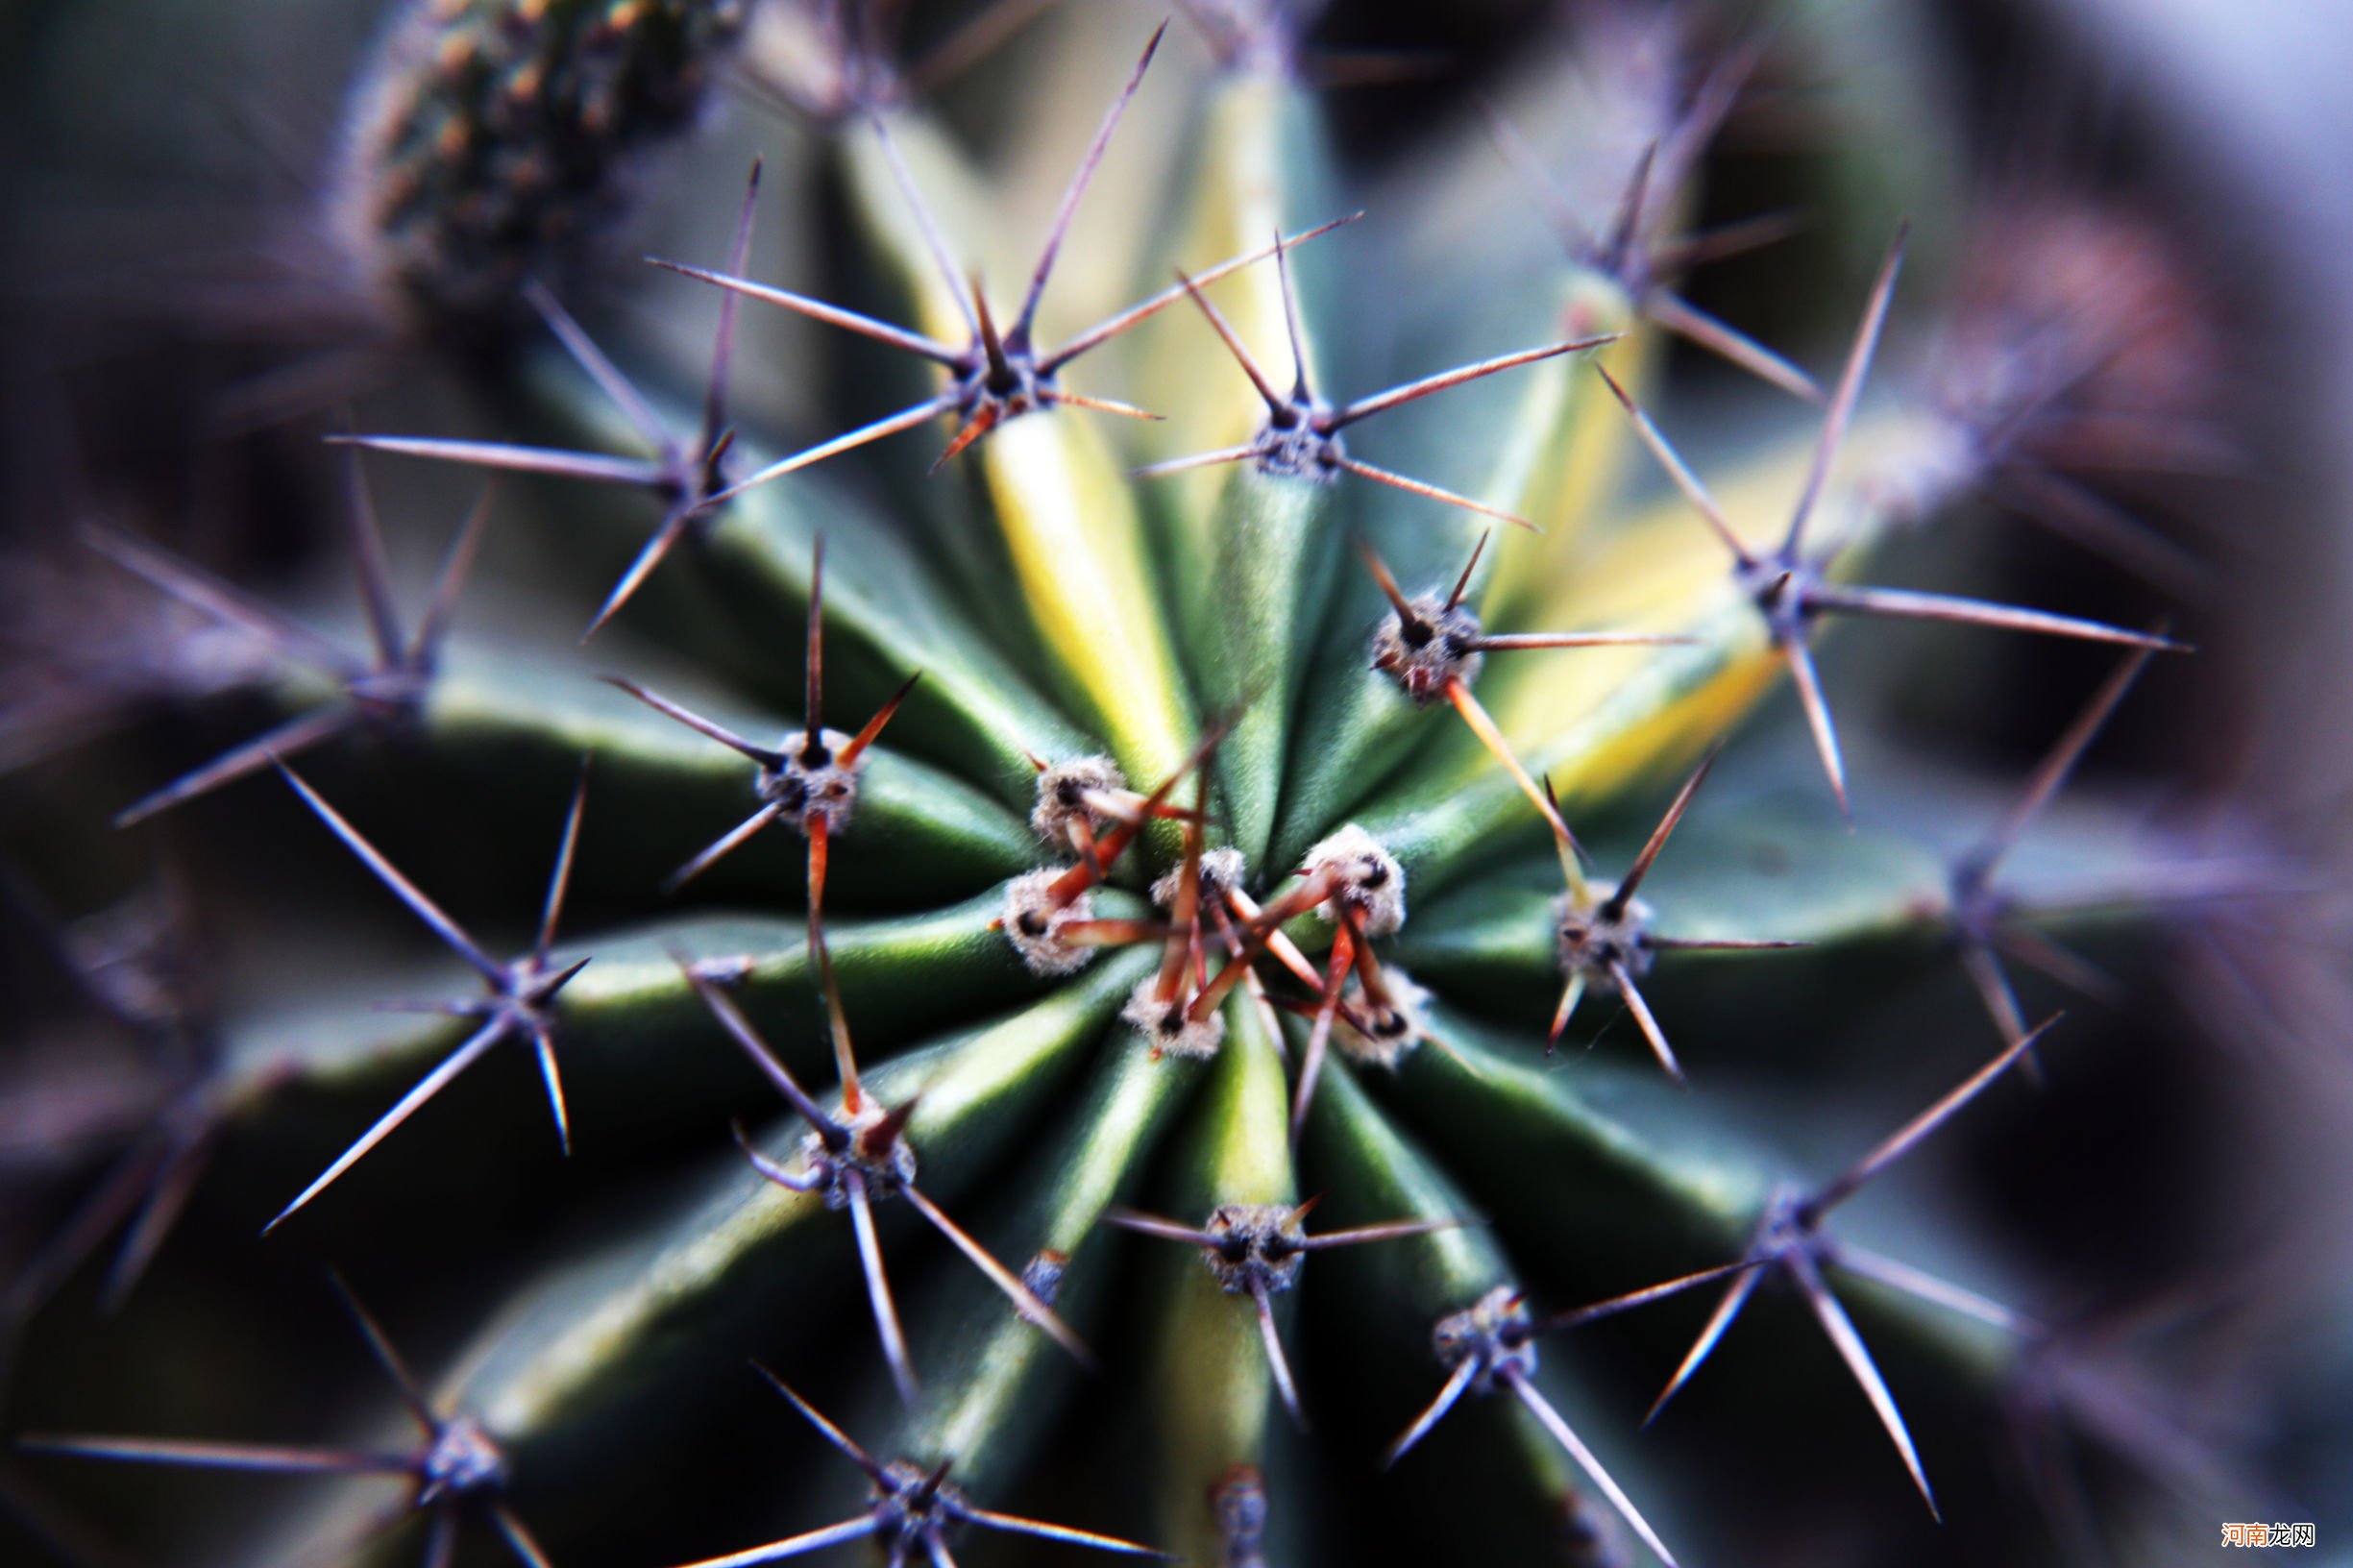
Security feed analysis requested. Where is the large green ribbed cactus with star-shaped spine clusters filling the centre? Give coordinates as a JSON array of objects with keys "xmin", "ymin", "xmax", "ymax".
[{"xmin": 7, "ymin": 0, "xmax": 2280, "ymax": 1568}]
